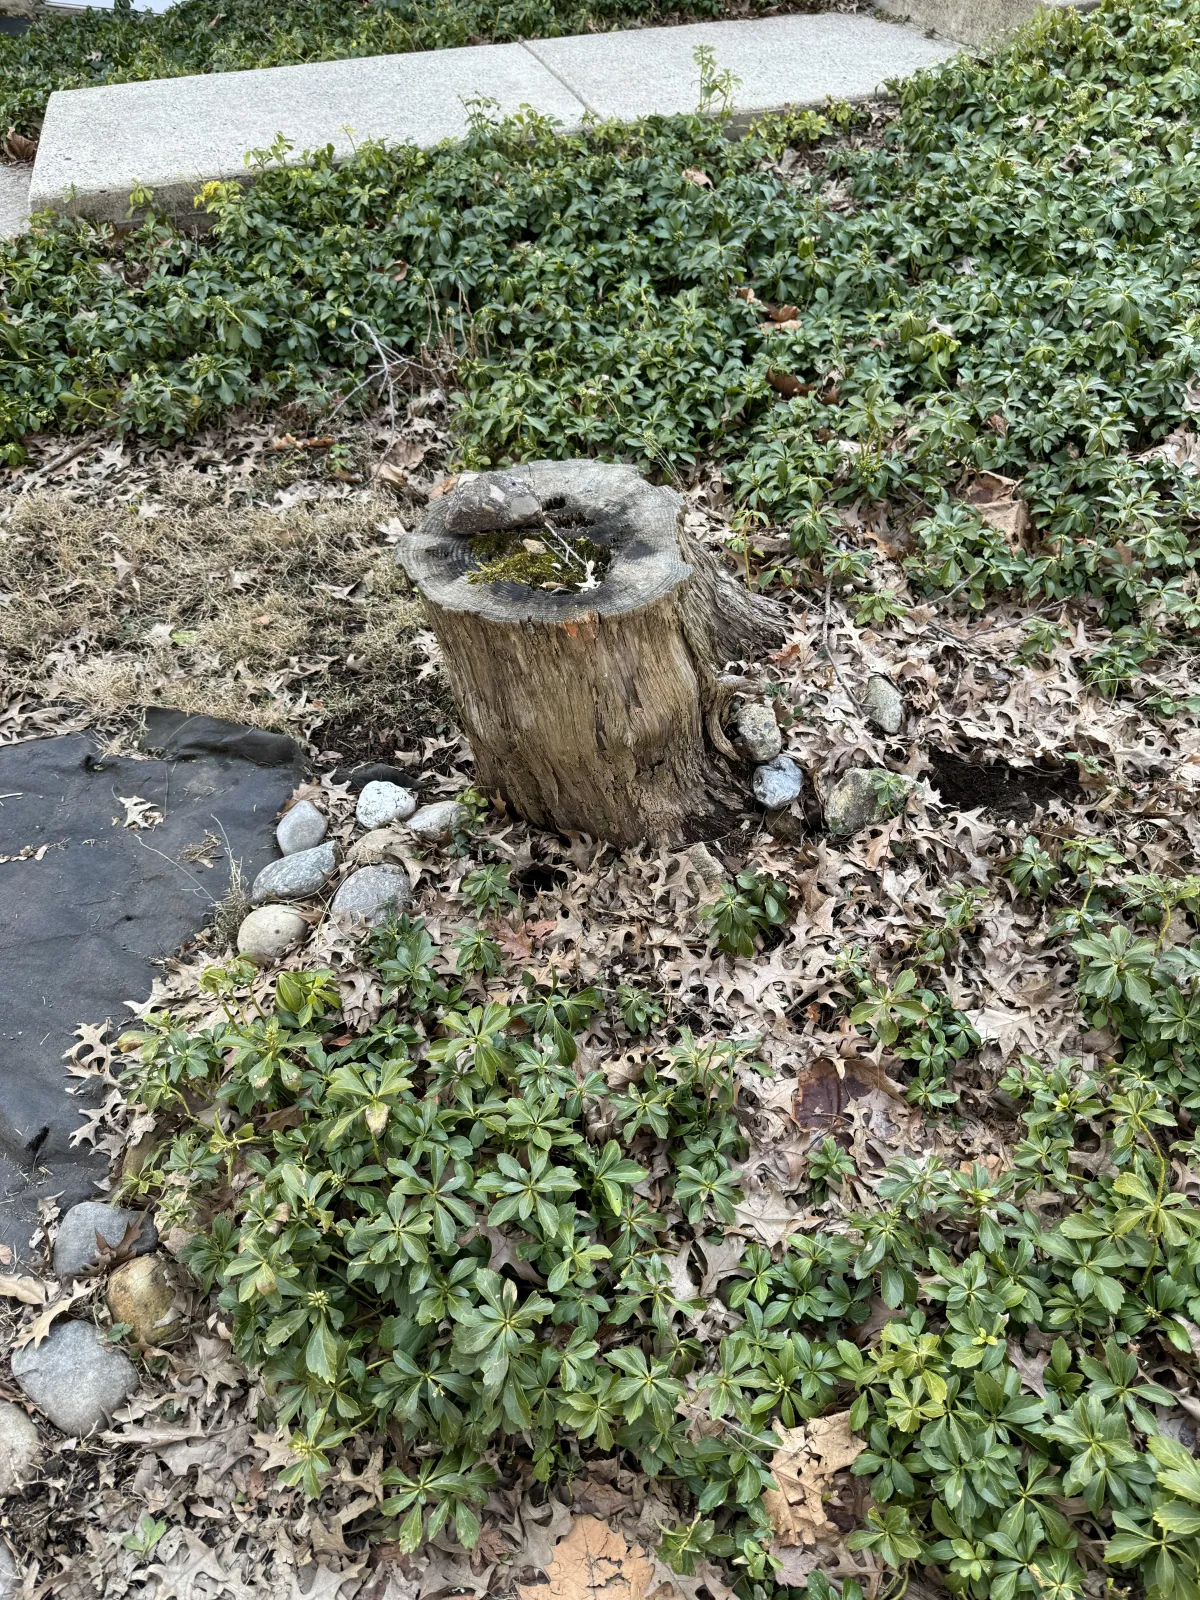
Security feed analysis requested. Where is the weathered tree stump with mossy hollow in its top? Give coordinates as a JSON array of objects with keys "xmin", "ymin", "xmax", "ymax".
[{"xmin": 398, "ymin": 461, "xmax": 784, "ymax": 845}]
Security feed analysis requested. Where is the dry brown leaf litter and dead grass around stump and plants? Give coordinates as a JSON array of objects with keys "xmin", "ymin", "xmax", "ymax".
[{"xmin": 0, "ymin": 387, "xmax": 1200, "ymax": 1600}]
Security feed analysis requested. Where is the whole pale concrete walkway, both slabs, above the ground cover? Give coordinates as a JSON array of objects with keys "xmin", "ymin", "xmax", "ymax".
[{"xmin": 21, "ymin": 13, "xmax": 958, "ymax": 230}]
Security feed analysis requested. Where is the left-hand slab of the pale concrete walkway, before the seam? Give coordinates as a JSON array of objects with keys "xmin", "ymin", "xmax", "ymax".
[{"xmin": 30, "ymin": 45, "xmax": 582, "ymax": 221}]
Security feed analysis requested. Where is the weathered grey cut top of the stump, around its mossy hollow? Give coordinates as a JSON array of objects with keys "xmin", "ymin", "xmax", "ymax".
[{"xmin": 402, "ymin": 461, "xmax": 691, "ymax": 622}]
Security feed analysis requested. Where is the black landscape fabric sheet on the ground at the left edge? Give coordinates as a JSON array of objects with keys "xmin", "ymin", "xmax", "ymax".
[{"xmin": 0, "ymin": 712, "xmax": 301, "ymax": 1258}]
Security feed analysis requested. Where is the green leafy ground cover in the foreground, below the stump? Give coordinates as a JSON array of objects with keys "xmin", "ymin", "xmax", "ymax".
[{"xmin": 115, "ymin": 837, "xmax": 1200, "ymax": 1600}]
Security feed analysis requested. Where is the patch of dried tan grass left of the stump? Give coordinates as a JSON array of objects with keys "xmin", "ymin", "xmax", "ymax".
[{"xmin": 0, "ymin": 441, "xmax": 448, "ymax": 757}]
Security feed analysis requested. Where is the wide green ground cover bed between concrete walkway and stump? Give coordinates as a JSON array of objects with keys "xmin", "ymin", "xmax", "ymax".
[{"xmin": 0, "ymin": 0, "xmax": 1200, "ymax": 630}]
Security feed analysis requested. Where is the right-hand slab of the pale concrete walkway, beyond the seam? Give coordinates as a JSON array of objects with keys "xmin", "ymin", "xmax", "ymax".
[{"xmin": 525, "ymin": 13, "xmax": 955, "ymax": 122}]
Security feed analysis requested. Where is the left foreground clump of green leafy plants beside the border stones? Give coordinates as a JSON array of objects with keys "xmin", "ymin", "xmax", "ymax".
[{"xmin": 125, "ymin": 920, "xmax": 770, "ymax": 1549}]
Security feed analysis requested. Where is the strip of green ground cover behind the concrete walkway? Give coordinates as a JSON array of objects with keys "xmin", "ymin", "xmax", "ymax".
[{"xmin": 0, "ymin": 0, "xmax": 800, "ymax": 134}]
